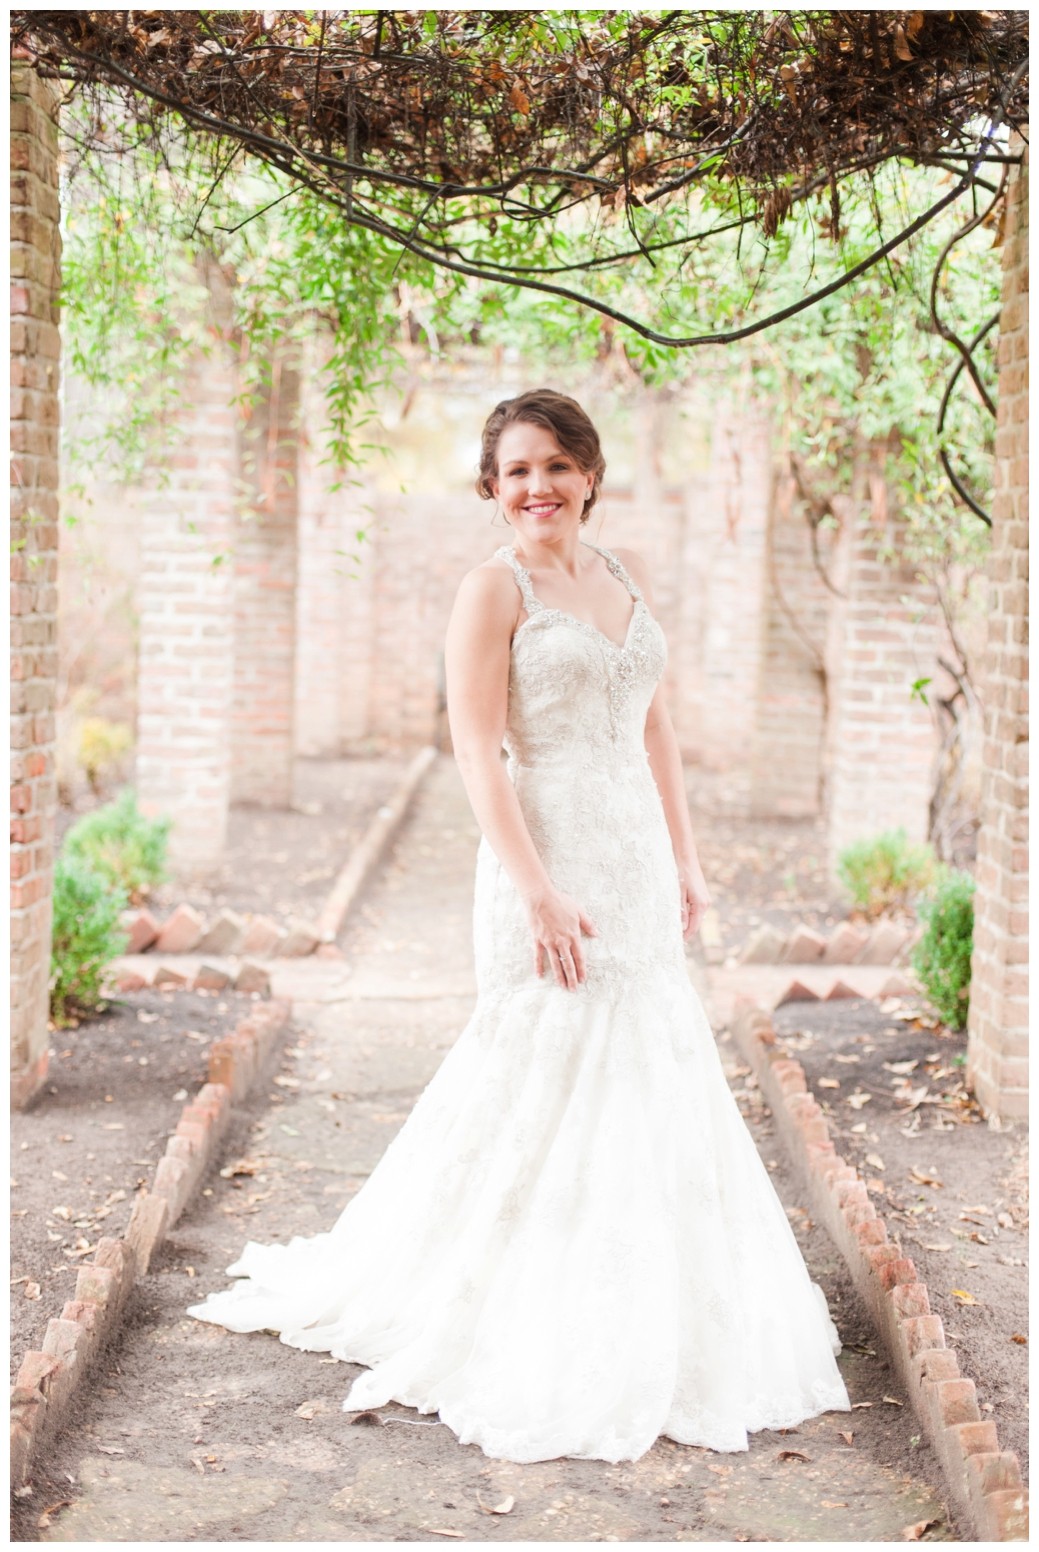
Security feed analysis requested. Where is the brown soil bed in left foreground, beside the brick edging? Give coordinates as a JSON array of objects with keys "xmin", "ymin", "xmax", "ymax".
[{"xmin": 11, "ymin": 989, "xmax": 259, "ymax": 1377}]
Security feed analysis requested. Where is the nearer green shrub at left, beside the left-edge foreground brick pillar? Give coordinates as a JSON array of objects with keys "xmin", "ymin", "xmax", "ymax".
[{"xmin": 50, "ymin": 855, "xmax": 129, "ymax": 1024}]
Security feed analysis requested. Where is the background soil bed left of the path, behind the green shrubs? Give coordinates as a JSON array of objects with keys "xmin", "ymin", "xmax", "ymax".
[{"xmin": 57, "ymin": 754, "xmax": 407, "ymax": 923}]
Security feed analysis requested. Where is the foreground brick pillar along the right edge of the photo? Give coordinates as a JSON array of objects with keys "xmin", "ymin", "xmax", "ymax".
[{"xmin": 968, "ymin": 141, "xmax": 1028, "ymax": 1117}]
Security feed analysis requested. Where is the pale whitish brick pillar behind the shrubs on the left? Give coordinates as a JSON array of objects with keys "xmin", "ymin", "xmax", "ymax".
[{"xmin": 137, "ymin": 270, "xmax": 238, "ymax": 880}]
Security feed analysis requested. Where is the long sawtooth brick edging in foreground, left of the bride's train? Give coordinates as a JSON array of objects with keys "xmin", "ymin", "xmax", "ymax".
[{"xmin": 11, "ymin": 999, "xmax": 292, "ymax": 1488}]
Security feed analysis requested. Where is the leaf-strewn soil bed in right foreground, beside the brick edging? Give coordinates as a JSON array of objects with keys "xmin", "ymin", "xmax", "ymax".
[{"xmin": 773, "ymin": 999, "xmax": 1028, "ymax": 1474}]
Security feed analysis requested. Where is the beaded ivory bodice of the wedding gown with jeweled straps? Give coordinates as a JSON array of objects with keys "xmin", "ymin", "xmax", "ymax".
[{"xmin": 495, "ymin": 540, "xmax": 666, "ymax": 770}]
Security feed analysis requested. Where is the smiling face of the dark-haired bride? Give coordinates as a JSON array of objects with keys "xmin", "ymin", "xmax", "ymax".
[{"xmin": 491, "ymin": 421, "xmax": 595, "ymax": 545}]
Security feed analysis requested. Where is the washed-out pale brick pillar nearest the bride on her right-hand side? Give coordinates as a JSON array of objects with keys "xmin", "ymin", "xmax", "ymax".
[{"xmin": 686, "ymin": 400, "xmax": 772, "ymax": 782}]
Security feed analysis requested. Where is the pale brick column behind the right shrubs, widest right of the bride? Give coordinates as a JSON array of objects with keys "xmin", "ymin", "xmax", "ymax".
[{"xmin": 828, "ymin": 447, "xmax": 936, "ymax": 874}]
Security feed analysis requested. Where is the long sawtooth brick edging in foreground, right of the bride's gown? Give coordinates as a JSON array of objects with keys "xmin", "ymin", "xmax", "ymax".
[{"xmin": 731, "ymin": 999, "xmax": 1028, "ymax": 1541}]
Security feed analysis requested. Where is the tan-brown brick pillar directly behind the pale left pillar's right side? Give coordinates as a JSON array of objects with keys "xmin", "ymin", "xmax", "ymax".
[{"xmin": 231, "ymin": 354, "xmax": 300, "ymax": 807}]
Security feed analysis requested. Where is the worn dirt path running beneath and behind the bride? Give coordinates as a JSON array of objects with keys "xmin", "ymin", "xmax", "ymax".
[{"xmin": 16, "ymin": 762, "xmax": 963, "ymax": 1541}]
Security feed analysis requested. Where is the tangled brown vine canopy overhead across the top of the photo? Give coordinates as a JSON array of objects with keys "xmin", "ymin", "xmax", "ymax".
[{"xmin": 12, "ymin": 9, "xmax": 1028, "ymax": 349}]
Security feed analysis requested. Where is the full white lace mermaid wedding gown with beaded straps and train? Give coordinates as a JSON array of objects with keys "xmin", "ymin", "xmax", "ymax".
[{"xmin": 188, "ymin": 545, "xmax": 851, "ymax": 1460}]
